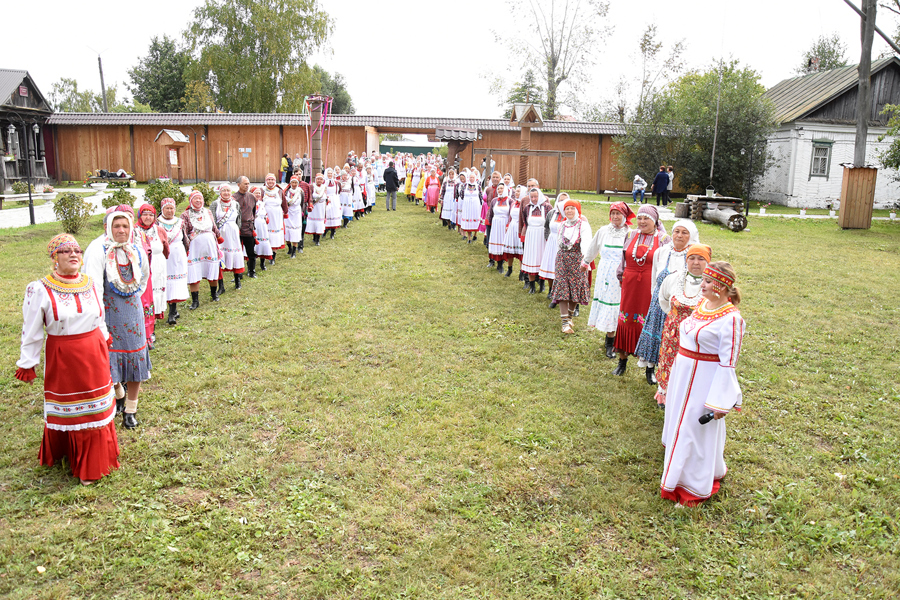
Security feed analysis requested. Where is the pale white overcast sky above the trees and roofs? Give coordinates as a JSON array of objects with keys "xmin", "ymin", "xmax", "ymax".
[{"xmin": 8, "ymin": 0, "xmax": 897, "ymax": 118}]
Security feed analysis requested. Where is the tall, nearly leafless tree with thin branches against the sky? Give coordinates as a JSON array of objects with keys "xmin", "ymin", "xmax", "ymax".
[{"xmin": 502, "ymin": 0, "xmax": 610, "ymax": 119}]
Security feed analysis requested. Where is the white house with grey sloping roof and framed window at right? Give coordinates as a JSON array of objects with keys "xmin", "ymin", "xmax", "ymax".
[{"xmin": 754, "ymin": 57, "xmax": 900, "ymax": 208}]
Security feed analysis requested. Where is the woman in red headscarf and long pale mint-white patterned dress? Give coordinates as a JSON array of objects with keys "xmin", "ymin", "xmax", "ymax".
[{"xmin": 584, "ymin": 202, "xmax": 635, "ymax": 358}]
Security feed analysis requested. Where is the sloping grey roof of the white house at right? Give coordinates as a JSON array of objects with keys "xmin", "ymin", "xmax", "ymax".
[{"xmin": 765, "ymin": 56, "xmax": 900, "ymax": 123}]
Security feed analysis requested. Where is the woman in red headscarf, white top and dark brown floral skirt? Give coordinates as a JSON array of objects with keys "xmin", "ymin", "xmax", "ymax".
[{"xmin": 550, "ymin": 200, "xmax": 592, "ymax": 334}]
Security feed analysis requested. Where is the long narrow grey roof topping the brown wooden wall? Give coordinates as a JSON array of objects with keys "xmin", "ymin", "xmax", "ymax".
[{"xmin": 48, "ymin": 113, "xmax": 625, "ymax": 135}]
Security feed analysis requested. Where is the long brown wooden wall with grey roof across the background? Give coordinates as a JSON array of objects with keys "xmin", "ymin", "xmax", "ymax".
[{"xmin": 48, "ymin": 113, "xmax": 632, "ymax": 192}]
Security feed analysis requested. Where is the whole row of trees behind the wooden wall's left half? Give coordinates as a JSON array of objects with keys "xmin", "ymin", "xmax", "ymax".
[{"xmin": 50, "ymin": 0, "xmax": 355, "ymax": 114}]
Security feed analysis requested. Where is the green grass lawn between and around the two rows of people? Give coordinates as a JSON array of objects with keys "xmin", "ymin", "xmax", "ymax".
[{"xmin": 0, "ymin": 198, "xmax": 900, "ymax": 600}]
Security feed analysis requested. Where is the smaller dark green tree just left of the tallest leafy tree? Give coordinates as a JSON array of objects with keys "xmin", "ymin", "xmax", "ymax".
[{"xmin": 128, "ymin": 35, "xmax": 191, "ymax": 112}]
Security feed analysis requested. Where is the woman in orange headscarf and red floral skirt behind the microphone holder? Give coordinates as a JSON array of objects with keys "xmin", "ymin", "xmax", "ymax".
[{"xmin": 656, "ymin": 244, "xmax": 712, "ymax": 407}]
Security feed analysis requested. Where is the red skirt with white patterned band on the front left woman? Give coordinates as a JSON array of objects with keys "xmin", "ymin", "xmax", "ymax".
[{"xmin": 38, "ymin": 328, "xmax": 119, "ymax": 480}]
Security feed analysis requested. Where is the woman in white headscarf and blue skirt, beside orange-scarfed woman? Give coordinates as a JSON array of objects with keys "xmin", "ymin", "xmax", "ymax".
[{"xmin": 634, "ymin": 219, "xmax": 700, "ymax": 385}]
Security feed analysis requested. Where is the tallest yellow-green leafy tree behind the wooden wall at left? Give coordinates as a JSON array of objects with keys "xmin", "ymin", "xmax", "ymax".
[{"xmin": 185, "ymin": 0, "xmax": 333, "ymax": 112}]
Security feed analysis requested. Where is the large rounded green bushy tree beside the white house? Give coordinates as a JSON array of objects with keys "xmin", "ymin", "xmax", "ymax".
[{"xmin": 619, "ymin": 61, "xmax": 776, "ymax": 196}]
